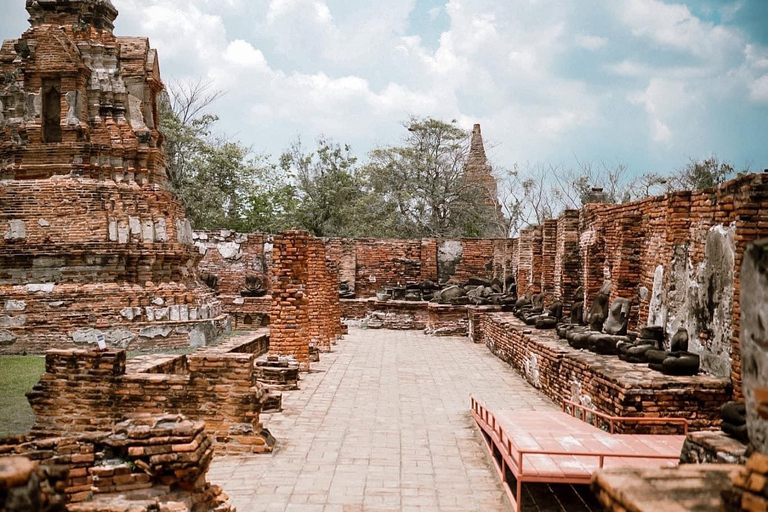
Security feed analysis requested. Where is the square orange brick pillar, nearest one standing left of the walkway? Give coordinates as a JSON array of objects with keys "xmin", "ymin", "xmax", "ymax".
[{"xmin": 269, "ymin": 231, "xmax": 310, "ymax": 370}]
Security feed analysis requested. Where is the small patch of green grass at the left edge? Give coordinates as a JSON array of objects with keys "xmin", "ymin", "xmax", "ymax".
[{"xmin": 0, "ymin": 356, "xmax": 45, "ymax": 437}]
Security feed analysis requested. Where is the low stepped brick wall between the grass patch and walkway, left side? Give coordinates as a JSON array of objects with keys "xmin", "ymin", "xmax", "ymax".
[{"xmin": 27, "ymin": 332, "xmax": 271, "ymax": 454}]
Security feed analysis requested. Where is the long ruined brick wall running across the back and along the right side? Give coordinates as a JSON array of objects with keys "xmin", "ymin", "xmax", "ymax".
[{"xmin": 326, "ymin": 173, "xmax": 768, "ymax": 398}]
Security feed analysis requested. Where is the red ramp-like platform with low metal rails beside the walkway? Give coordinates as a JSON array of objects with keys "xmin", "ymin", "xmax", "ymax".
[{"xmin": 471, "ymin": 398, "xmax": 688, "ymax": 512}]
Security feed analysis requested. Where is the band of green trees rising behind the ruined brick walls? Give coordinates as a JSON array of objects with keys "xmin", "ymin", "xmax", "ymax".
[{"xmin": 160, "ymin": 81, "xmax": 748, "ymax": 238}]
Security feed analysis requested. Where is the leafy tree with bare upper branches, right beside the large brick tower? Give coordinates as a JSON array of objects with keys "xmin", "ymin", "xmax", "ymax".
[{"xmin": 160, "ymin": 81, "xmax": 295, "ymax": 231}]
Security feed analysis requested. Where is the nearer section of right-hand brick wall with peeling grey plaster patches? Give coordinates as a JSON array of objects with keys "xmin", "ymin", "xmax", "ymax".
[{"xmin": 568, "ymin": 173, "xmax": 768, "ymax": 390}]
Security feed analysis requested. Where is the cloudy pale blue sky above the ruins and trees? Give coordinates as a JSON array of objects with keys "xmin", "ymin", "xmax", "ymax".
[{"xmin": 0, "ymin": 0, "xmax": 768, "ymax": 173}]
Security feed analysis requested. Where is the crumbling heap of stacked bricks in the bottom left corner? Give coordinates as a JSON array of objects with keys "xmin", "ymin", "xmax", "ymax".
[{"xmin": 0, "ymin": 415, "xmax": 233, "ymax": 512}]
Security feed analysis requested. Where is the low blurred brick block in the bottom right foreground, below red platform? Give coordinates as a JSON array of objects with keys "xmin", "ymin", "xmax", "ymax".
[{"xmin": 592, "ymin": 464, "xmax": 741, "ymax": 512}]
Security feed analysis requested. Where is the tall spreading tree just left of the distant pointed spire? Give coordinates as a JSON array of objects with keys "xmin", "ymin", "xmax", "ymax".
[{"xmin": 364, "ymin": 117, "xmax": 492, "ymax": 238}]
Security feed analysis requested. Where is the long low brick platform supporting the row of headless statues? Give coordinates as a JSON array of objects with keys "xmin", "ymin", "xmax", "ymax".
[{"xmin": 480, "ymin": 313, "xmax": 731, "ymax": 433}]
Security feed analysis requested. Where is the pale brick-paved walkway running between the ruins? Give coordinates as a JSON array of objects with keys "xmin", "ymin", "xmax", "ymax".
[{"xmin": 209, "ymin": 329, "xmax": 592, "ymax": 512}]
